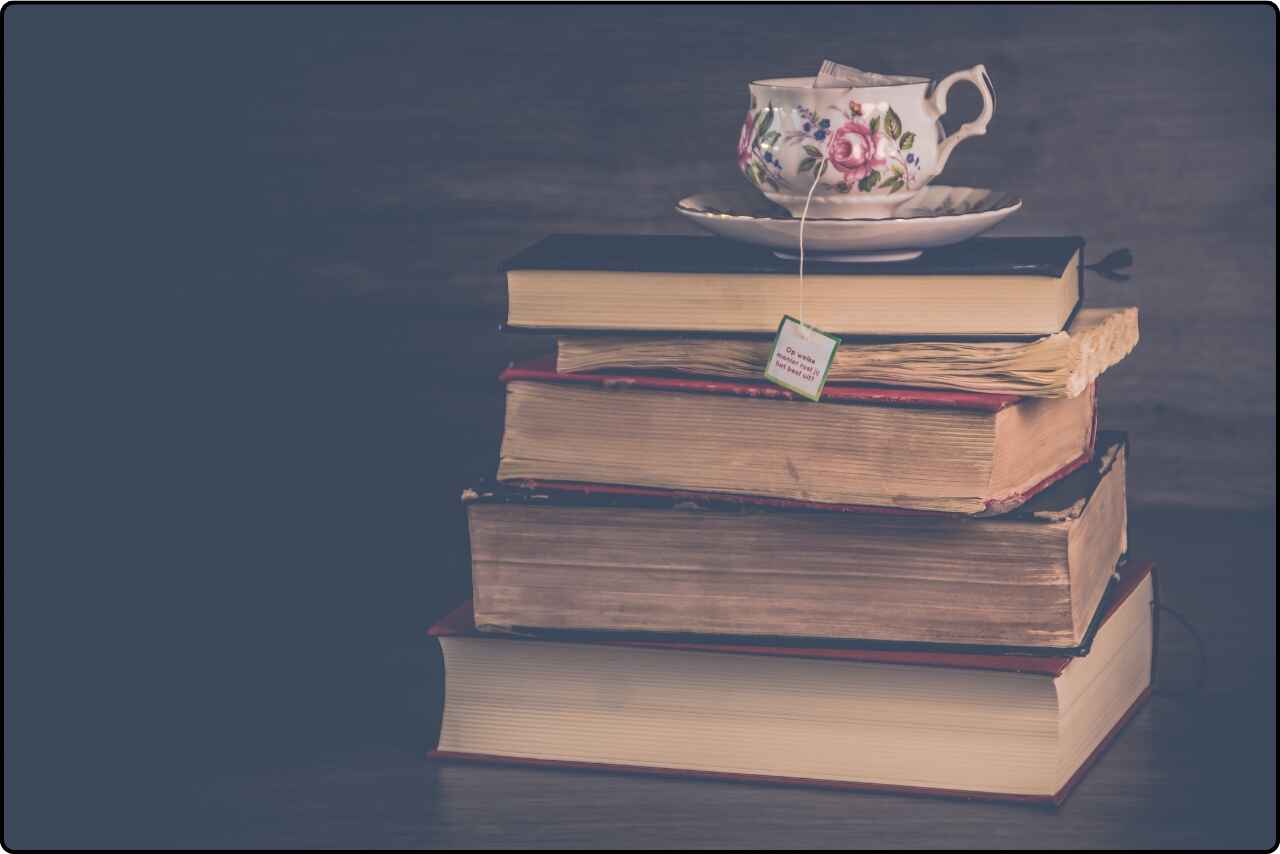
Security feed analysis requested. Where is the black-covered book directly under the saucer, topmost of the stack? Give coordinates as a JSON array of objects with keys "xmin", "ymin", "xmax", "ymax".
[{"xmin": 506, "ymin": 234, "xmax": 1084, "ymax": 337}]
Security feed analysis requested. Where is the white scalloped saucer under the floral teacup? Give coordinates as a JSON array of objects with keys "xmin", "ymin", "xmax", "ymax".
[{"xmin": 676, "ymin": 184, "xmax": 1023, "ymax": 261}]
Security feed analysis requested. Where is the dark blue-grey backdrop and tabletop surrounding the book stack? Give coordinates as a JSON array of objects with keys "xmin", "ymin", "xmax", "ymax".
[{"xmin": 4, "ymin": 4, "xmax": 1276, "ymax": 848}]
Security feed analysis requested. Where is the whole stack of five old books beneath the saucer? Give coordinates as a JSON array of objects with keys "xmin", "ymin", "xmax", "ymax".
[{"xmin": 431, "ymin": 236, "xmax": 1155, "ymax": 802}]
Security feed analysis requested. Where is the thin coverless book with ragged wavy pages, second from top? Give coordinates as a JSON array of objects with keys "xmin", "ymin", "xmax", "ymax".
[{"xmin": 556, "ymin": 306, "xmax": 1138, "ymax": 397}]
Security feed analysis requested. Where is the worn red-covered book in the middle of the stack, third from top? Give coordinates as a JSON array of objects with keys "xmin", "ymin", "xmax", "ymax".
[{"xmin": 498, "ymin": 359, "xmax": 1097, "ymax": 515}]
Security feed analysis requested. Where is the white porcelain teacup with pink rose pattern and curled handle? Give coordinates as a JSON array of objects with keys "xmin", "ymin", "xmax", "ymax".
[{"xmin": 737, "ymin": 65, "xmax": 996, "ymax": 219}]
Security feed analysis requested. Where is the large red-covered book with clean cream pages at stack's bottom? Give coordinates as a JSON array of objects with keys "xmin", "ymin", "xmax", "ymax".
[{"xmin": 430, "ymin": 561, "xmax": 1155, "ymax": 804}]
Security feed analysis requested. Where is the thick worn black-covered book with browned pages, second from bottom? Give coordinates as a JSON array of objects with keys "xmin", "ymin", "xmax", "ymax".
[{"xmin": 463, "ymin": 433, "xmax": 1128, "ymax": 648}]
